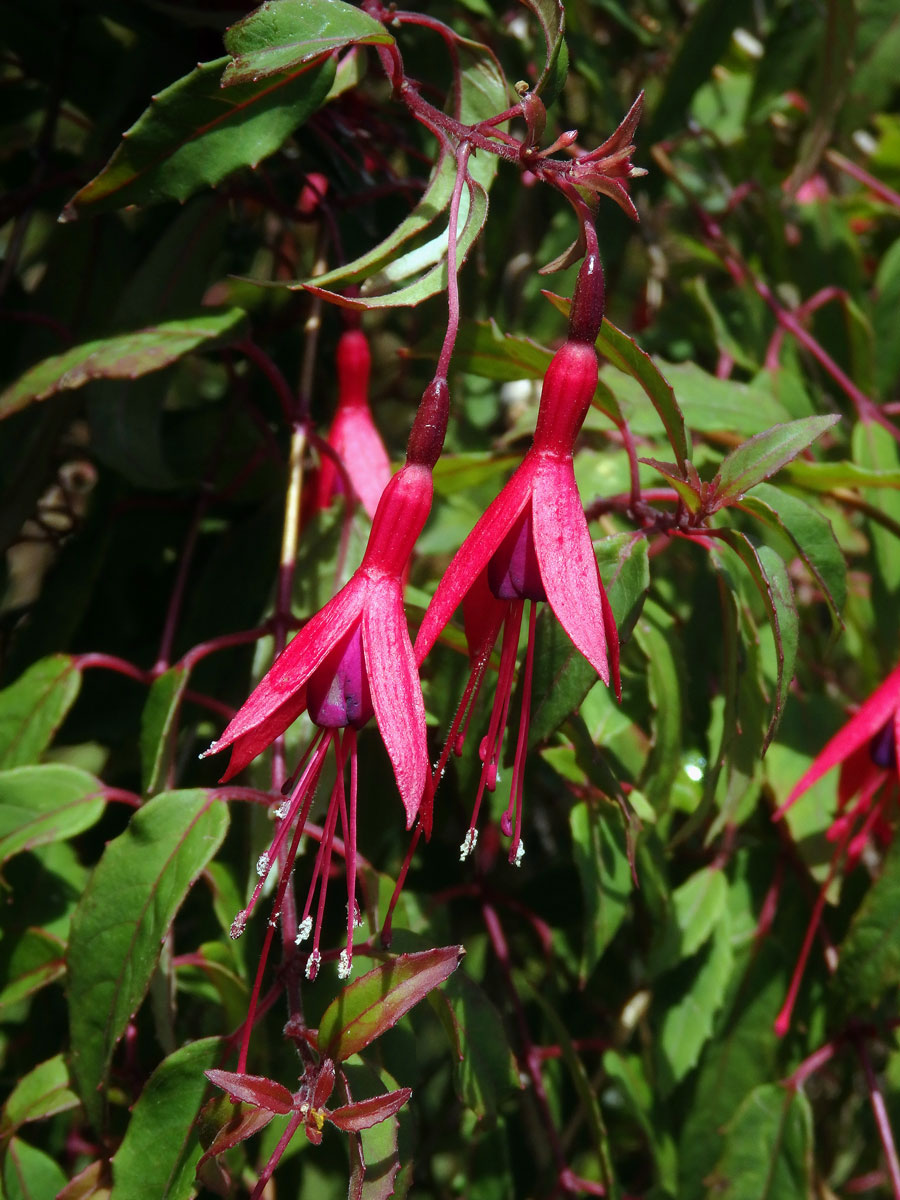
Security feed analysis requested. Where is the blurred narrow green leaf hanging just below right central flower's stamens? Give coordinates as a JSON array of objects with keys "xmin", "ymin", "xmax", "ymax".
[{"xmin": 569, "ymin": 802, "xmax": 634, "ymax": 985}]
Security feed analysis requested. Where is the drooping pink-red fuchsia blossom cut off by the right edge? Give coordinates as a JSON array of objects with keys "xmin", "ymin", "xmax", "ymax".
[{"xmin": 775, "ymin": 666, "xmax": 900, "ymax": 1034}]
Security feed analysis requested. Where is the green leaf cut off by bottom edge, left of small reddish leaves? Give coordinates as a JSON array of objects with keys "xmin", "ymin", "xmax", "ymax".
[{"xmin": 110, "ymin": 1038, "xmax": 222, "ymax": 1200}]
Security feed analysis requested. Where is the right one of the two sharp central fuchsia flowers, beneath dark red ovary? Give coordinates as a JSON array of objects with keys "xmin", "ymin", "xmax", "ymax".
[{"xmin": 415, "ymin": 333, "xmax": 619, "ymax": 864}]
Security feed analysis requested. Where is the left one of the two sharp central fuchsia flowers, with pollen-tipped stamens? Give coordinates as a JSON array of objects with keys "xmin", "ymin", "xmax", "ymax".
[{"xmin": 206, "ymin": 463, "xmax": 432, "ymax": 979}]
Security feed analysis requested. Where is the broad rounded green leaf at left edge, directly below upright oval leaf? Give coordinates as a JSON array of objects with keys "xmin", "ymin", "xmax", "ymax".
[{"xmin": 0, "ymin": 763, "xmax": 106, "ymax": 863}]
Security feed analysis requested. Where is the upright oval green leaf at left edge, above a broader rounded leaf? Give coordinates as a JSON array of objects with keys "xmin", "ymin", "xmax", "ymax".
[{"xmin": 0, "ymin": 654, "xmax": 82, "ymax": 769}]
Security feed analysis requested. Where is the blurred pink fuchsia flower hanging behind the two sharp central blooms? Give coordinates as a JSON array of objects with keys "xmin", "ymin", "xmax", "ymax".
[{"xmin": 316, "ymin": 329, "xmax": 391, "ymax": 518}]
